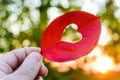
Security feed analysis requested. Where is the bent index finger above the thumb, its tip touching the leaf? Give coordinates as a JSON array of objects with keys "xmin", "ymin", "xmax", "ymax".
[{"xmin": 0, "ymin": 47, "xmax": 41, "ymax": 74}]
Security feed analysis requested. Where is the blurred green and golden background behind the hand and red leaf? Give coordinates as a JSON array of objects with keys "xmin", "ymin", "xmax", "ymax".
[{"xmin": 0, "ymin": 0, "xmax": 120, "ymax": 80}]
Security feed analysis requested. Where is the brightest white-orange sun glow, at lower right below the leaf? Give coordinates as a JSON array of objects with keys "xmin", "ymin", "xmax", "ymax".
[{"xmin": 80, "ymin": 47, "xmax": 115, "ymax": 73}]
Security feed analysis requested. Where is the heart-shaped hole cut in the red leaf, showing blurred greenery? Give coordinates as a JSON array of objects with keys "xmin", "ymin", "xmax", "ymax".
[{"xmin": 61, "ymin": 24, "xmax": 82, "ymax": 43}]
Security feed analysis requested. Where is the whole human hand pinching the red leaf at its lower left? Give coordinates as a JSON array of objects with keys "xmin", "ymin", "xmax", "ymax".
[{"xmin": 0, "ymin": 47, "xmax": 48, "ymax": 80}]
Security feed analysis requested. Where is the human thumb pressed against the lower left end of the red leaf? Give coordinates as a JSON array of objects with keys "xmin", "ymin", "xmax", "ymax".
[{"xmin": 12, "ymin": 52, "xmax": 42, "ymax": 80}]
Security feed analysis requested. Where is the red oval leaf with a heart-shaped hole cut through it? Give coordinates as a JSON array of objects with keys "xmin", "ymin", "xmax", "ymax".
[{"xmin": 41, "ymin": 11, "xmax": 101, "ymax": 62}]
